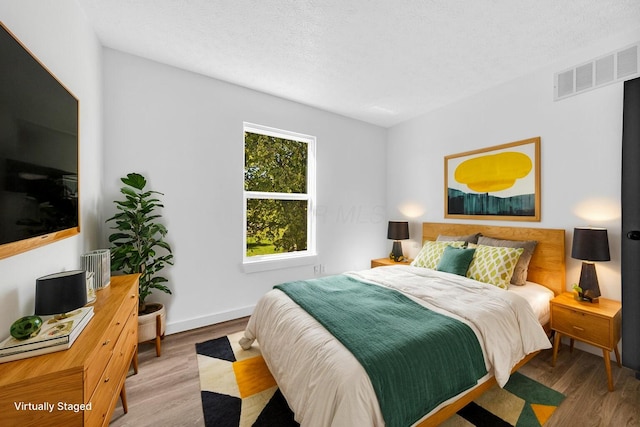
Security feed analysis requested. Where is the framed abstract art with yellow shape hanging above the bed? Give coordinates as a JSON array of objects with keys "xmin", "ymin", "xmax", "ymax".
[{"xmin": 444, "ymin": 137, "xmax": 540, "ymax": 221}]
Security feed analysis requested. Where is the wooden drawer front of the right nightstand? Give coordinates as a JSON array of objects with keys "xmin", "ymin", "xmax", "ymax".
[{"xmin": 551, "ymin": 305, "xmax": 612, "ymax": 349}]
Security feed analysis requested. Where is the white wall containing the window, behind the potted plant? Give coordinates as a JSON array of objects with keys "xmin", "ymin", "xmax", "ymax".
[{"xmin": 103, "ymin": 49, "xmax": 388, "ymax": 333}]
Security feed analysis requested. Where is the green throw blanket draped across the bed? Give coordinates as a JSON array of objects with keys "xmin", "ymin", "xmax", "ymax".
[{"xmin": 275, "ymin": 275, "xmax": 487, "ymax": 427}]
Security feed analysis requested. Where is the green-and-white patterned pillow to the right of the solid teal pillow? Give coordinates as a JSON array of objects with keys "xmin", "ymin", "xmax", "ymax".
[{"xmin": 467, "ymin": 245, "xmax": 524, "ymax": 289}]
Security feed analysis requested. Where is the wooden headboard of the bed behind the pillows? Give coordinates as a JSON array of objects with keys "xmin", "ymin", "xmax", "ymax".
[{"xmin": 422, "ymin": 222, "xmax": 566, "ymax": 295}]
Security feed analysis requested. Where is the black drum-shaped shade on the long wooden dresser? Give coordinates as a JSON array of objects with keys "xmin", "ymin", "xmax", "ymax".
[{"xmin": 35, "ymin": 270, "xmax": 87, "ymax": 316}]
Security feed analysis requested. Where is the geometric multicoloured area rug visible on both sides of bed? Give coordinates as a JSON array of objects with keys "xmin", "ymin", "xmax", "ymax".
[{"xmin": 196, "ymin": 332, "xmax": 564, "ymax": 427}]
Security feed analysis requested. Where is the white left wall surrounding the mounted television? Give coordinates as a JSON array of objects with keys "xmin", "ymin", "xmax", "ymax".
[{"xmin": 0, "ymin": 0, "xmax": 102, "ymax": 338}]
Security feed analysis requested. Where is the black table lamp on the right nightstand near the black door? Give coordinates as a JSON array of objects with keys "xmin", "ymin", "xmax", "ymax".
[{"xmin": 571, "ymin": 227, "xmax": 611, "ymax": 302}]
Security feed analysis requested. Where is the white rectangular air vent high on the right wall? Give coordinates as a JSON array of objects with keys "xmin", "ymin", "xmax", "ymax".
[{"xmin": 553, "ymin": 43, "xmax": 640, "ymax": 101}]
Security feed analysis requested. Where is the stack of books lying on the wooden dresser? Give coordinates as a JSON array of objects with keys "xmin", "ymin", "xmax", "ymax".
[{"xmin": 0, "ymin": 306, "xmax": 93, "ymax": 363}]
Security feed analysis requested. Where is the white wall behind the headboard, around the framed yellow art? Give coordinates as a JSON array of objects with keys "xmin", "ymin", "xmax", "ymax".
[{"xmin": 387, "ymin": 28, "xmax": 640, "ymax": 356}]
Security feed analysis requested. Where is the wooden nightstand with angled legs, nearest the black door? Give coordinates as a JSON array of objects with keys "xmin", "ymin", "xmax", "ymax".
[{"xmin": 551, "ymin": 292, "xmax": 622, "ymax": 391}]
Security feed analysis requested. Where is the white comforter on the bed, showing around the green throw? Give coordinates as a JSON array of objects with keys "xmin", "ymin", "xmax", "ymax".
[{"xmin": 241, "ymin": 266, "xmax": 550, "ymax": 426}]
